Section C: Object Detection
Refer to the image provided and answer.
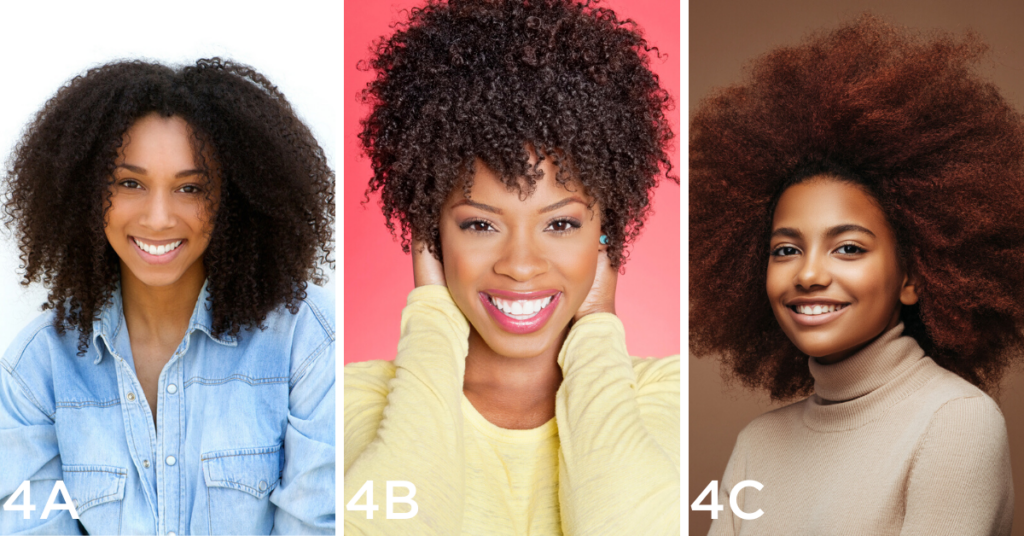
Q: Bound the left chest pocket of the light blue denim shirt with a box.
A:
[62,465,128,534]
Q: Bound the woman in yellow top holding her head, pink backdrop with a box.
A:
[345,0,680,535]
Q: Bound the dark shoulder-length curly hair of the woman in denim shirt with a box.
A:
[3,57,334,353]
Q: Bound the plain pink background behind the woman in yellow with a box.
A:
[343,0,680,363]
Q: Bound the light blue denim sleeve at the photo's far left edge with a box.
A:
[0,360,81,534]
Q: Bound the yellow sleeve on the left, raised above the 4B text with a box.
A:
[344,285,469,536]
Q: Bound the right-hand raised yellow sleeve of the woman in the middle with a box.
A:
[555,313,680,535]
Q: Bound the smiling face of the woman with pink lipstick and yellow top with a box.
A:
[439,159,601,358]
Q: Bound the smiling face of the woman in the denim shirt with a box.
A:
[103,114,216,287]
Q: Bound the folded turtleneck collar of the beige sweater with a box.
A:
[804,323,941,431]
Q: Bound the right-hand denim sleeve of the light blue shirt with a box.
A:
[270,320,336,534]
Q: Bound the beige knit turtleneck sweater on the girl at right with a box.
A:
[703,324,1021,536]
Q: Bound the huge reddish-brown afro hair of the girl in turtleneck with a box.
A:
[689,15,1024,399]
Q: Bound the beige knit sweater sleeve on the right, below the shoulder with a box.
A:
[900,397,1014,536]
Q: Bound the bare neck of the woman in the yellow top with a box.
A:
[463,326,568,412]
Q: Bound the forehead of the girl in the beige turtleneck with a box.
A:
[772,177,892,234]
